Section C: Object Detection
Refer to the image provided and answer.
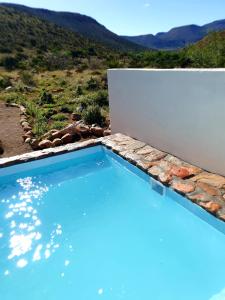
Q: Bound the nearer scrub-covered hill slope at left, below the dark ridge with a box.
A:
[0,5,123,70]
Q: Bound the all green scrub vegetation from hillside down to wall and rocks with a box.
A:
[0,6,225,143]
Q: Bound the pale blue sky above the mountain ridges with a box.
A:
[2,0,225,35]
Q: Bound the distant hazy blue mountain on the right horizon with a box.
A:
[124,20,225,50]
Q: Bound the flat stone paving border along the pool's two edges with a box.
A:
[0,133,225,221]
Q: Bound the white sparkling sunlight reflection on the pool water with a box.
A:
[0,177,62,275]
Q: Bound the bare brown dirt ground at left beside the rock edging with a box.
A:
[0,102,32,158]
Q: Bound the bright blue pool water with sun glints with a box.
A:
[0,146,225,300]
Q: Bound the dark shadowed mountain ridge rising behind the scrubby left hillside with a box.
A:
[0,3,143,51]
